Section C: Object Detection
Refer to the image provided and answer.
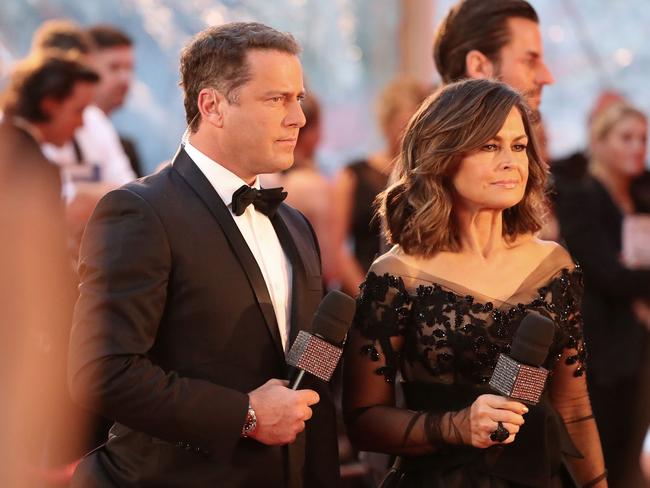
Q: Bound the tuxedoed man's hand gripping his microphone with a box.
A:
[248,379,320,446]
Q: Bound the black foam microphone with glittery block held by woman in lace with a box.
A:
[490,314,555,405]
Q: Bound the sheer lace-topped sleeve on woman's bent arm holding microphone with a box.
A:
[343,272,469,455]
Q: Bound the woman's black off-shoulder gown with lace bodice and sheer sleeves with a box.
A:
[343,258,604,488]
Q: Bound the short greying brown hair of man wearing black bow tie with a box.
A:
[180,22,300,132]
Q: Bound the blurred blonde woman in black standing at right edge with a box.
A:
[556,103,650,487]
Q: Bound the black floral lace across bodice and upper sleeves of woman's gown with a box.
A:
[353,265,585,385]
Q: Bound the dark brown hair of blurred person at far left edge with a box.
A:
[0,50,99,122]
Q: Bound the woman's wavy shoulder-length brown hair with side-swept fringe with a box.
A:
[376,80,548,257]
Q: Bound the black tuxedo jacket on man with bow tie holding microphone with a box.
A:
[69,148,338,487]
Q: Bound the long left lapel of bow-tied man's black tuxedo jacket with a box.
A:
[173,147,285,362]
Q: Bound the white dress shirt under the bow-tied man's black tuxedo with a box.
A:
[185,141,292,351]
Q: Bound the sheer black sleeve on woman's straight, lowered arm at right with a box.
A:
[549,268,606,486]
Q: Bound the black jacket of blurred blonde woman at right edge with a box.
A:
[556,176,650,386]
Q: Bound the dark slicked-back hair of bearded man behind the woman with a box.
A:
[433,0,539,83]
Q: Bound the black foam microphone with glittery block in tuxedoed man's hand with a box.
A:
[287,290,356,390]
